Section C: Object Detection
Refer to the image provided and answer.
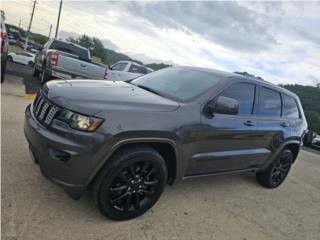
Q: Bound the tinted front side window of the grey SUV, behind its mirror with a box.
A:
[220,83,255,114]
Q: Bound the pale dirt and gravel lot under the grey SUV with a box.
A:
[1,75,320,240]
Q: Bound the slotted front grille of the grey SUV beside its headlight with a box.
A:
[33,93,59,125]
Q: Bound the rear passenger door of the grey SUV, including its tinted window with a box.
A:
[256,86,284,158]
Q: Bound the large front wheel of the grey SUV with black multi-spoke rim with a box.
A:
[93,146,168,220]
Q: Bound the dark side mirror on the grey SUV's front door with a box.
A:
[204,96,239,115]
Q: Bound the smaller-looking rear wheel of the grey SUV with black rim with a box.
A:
[256,149,293,188]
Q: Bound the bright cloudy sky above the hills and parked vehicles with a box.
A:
[1,0,320,86]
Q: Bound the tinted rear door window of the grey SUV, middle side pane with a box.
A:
[257,87,281,117]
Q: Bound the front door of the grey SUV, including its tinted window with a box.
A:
[187,82,267,175]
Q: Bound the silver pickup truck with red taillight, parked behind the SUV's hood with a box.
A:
[33,39,108,84]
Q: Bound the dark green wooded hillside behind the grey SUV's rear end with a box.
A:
[281,84,320,134]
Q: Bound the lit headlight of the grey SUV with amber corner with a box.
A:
[58,110,103,132]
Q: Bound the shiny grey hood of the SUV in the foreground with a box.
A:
[44,80,179,115]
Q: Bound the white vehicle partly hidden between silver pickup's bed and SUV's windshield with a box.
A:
[108,61,152,81]
